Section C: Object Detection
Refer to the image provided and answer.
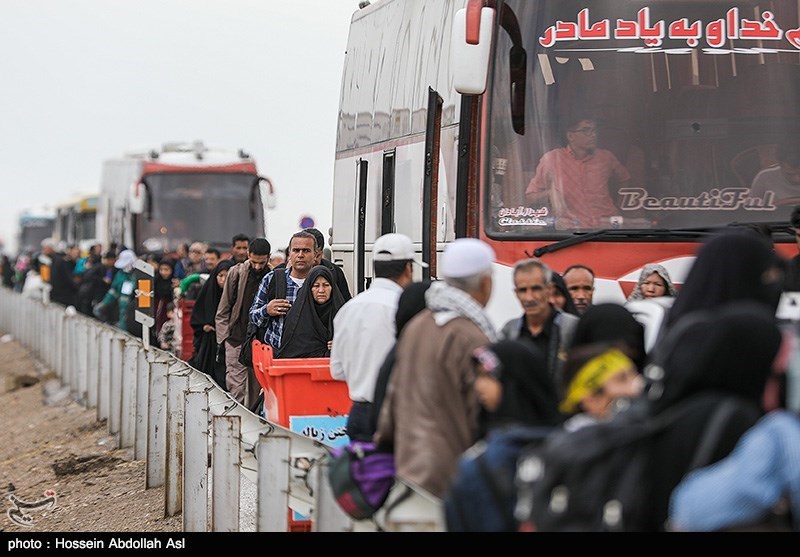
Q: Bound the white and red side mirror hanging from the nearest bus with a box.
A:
[450,4,495,95]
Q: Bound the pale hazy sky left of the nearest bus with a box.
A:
[0,0,358,254]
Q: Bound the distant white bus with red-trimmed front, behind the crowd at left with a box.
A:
[97,141,275,253]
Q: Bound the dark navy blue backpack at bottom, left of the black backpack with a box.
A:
[443,426,554,532]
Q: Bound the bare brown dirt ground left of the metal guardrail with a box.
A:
[0,331,182,532]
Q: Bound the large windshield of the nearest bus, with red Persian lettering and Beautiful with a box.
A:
[483,0,800,239]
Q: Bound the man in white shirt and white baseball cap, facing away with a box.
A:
[330,233,428,441]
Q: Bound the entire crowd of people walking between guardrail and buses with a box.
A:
[4,213,800,531]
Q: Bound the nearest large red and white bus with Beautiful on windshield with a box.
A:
[331,0,800,323]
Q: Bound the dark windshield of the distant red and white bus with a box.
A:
[136,172,264,251]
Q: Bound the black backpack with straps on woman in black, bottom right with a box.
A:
[515,311,758,532]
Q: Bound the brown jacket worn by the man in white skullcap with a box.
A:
[375,309,489,497]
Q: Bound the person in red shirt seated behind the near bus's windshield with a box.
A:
[525,115,631,230]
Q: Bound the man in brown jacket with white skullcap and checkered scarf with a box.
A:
[376,238,497,497]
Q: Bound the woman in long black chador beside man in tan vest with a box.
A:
[190,259,234,390]
